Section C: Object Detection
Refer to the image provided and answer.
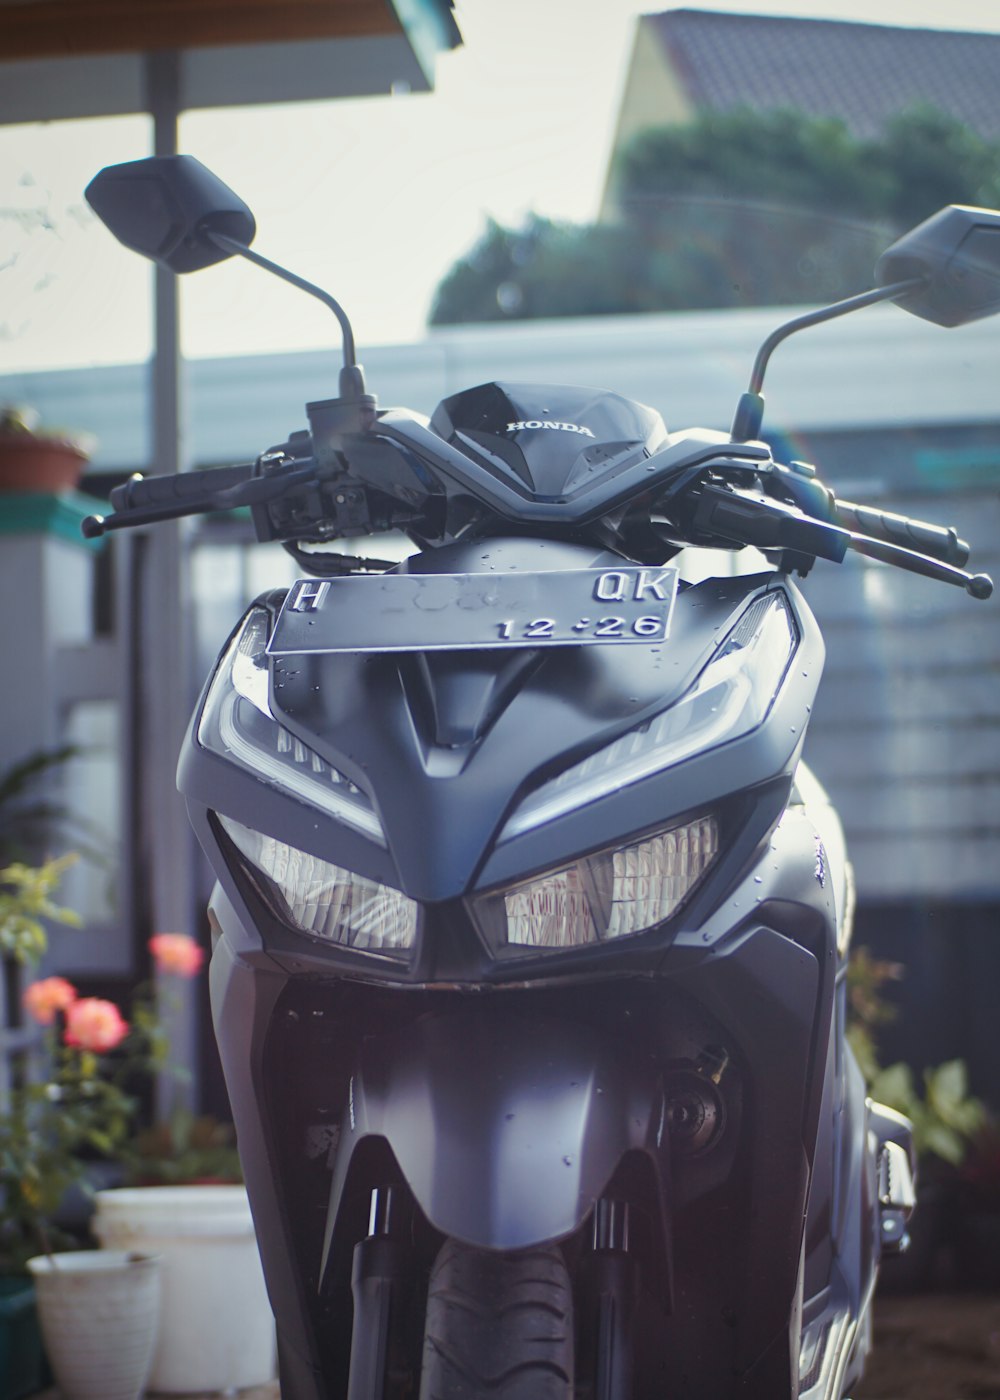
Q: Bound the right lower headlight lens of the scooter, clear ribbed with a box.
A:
[471,816,718,955]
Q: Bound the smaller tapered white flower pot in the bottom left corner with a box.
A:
[28,1249,160,1400]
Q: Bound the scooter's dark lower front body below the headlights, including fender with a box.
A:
[204,818,851,1400]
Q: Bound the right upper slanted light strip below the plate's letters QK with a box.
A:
[500,592,797,841]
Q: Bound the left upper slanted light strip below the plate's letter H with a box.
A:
[197,608,385,846]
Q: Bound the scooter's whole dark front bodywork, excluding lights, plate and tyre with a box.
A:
[181,534,870,1400]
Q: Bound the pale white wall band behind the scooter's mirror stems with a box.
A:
[0,307,1000,470]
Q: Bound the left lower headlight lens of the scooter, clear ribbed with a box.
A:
[217,813,419,958]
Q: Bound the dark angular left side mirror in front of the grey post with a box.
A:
[84,155,256,272]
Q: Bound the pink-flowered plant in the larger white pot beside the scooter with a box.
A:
[0,912,275,1400]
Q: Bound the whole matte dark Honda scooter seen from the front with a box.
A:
[85,157,1000,1400]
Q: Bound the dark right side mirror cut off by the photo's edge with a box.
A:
[875,204,1000,326]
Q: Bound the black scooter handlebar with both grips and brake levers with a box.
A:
[83,431,993,598]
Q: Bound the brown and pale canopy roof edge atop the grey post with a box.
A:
[0,0,461,123]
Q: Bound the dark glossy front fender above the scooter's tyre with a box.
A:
[325,1000,668,1254]
